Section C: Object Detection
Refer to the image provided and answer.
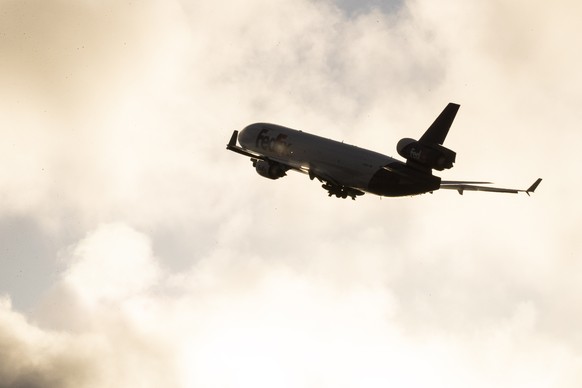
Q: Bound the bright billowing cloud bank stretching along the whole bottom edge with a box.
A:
[0,224,580,387]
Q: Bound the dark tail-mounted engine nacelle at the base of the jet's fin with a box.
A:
[396,138,457,171]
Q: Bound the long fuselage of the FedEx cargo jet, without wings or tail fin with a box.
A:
[238,123,440,197]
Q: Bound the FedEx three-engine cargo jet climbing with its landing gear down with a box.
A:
[226,103,542,200]
